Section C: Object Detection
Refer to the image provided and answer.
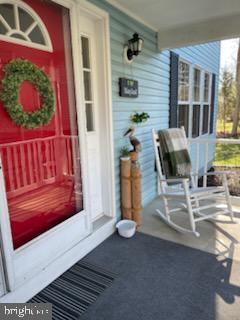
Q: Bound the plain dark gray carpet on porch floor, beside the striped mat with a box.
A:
[80,233,240,320]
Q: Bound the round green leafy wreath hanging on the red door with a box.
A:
[0,59,55,129]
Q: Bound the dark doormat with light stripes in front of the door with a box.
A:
[29,259,116,320]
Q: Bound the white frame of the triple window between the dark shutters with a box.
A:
[177,58,212,139]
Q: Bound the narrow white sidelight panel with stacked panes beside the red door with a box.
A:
[80,14,104,221]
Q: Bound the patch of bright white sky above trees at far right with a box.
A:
[220,39,238,74]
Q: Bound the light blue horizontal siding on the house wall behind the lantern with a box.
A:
[89,0,218,217]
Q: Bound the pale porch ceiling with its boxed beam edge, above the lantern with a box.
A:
[107,0,240,50]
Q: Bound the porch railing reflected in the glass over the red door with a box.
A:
[0,136,80,197]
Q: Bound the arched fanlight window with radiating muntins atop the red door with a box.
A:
[0,0,52,51]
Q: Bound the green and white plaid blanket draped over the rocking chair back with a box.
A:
[159,128,192,178]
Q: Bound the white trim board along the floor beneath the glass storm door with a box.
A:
[0,219,116,303]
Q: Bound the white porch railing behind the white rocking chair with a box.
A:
[188,138,240,196]
